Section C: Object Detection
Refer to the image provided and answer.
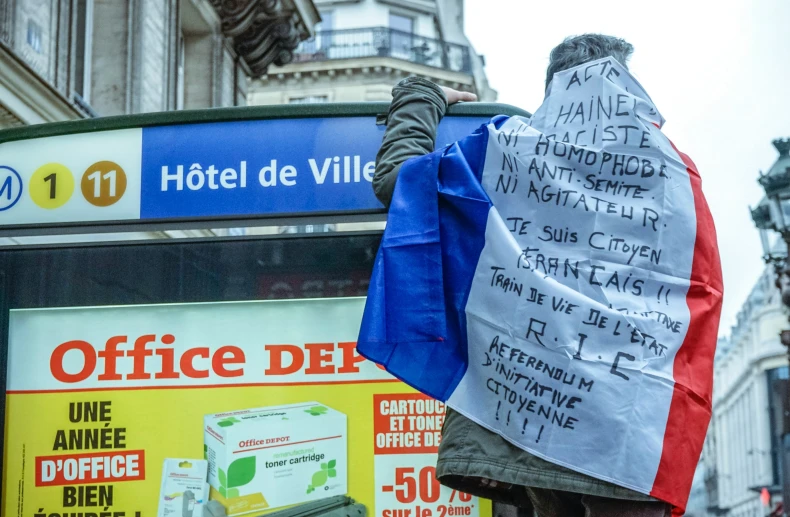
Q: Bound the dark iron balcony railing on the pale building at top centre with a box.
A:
[292,27,472,74]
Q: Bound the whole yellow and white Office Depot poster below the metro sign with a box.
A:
[0,298,490,517]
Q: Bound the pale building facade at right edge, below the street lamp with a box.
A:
[703,267,788,517]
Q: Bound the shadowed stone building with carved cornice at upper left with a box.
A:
[0,0,319,127]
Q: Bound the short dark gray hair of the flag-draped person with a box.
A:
[546,34,634,89]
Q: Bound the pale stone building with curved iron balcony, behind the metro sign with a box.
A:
[250,0,496,104]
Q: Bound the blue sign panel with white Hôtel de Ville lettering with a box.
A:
[140,117,488,220]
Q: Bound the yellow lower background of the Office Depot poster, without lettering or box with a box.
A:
[3,382,490,517]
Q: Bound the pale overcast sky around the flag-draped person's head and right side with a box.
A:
[465,0,790,334]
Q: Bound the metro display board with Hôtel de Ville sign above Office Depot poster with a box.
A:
[0,103,532,517]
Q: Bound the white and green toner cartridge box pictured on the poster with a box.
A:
[204,402,348,515]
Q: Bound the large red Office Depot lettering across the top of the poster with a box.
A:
[49,334,372,384]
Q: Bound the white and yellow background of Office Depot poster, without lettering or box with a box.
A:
[1,298,490,517]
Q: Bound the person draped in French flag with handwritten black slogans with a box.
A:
[358,35,723,517]
